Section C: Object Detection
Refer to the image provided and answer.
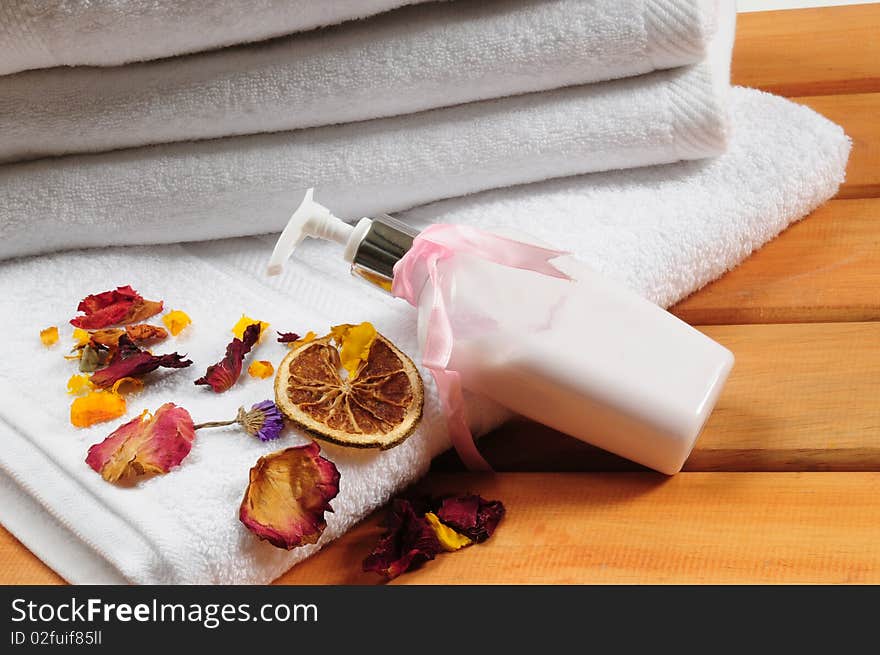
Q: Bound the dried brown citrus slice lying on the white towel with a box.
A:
[275,333,424,450]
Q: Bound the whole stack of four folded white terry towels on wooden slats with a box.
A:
[0,0,849,582]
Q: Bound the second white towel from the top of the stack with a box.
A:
[0,0,720,162]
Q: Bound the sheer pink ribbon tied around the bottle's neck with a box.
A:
[391,224,571,471]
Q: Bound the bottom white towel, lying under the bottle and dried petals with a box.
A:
[0,89,849,583]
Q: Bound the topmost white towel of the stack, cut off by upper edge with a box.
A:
[0,0,425,75]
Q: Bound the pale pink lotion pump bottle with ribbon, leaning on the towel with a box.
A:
[269,189,733,474]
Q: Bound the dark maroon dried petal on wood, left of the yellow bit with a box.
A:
[363,498,443,580]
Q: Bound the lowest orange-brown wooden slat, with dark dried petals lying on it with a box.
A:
[279,473,880,584]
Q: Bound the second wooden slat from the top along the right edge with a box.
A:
[795,93,880,198]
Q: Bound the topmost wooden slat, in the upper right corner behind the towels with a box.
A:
[733,4,880,96]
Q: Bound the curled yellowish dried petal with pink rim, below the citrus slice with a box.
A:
[238,442,339,550]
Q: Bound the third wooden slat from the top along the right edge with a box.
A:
[671,199,880,325]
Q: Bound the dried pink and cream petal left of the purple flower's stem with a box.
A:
[86,403,196,482]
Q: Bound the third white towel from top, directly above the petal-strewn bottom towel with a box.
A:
[0,8,733,258]
